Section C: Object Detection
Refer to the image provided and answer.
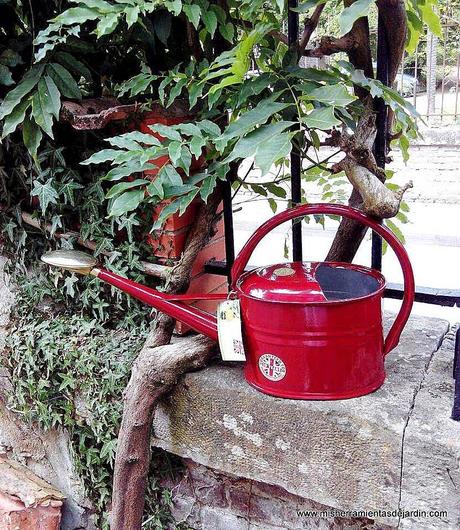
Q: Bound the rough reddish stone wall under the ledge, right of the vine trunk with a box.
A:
[165,460,390,530]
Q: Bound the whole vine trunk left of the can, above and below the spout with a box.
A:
[110,186,221,530]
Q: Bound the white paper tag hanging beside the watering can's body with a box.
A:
[217,300,246,361]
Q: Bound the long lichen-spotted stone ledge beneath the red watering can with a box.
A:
[154,317,460,528]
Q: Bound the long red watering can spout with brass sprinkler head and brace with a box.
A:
[41,250,219,341]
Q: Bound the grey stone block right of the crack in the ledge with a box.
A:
[400,328,460,530]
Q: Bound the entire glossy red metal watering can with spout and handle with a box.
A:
[42,204,414,399]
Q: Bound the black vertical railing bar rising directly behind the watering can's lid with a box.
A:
[288,0,302,261]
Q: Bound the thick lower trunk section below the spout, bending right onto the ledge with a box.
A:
[111,335,216,530]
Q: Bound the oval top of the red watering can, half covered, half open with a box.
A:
[235,261,385,304]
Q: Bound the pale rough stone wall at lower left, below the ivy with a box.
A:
[0,256,95,530]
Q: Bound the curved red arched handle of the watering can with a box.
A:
[231,204,415,355]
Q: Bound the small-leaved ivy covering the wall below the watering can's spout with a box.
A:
[4,284,184,530]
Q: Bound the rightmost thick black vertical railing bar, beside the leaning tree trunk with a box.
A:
[371,15,388,270]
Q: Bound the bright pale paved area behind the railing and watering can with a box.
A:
[235,142,460,321]
